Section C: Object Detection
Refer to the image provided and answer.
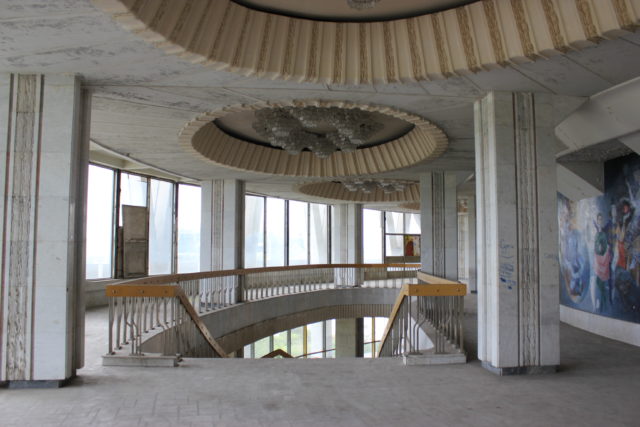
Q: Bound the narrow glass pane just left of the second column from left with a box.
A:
[178,184,200,273]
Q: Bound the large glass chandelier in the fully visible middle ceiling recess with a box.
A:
[253,107,384,158]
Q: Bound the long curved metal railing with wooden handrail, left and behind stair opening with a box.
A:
[106,264,420,357]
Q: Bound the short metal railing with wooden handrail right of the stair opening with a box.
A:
[378,272,467,357]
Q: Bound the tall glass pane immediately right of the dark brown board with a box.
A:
[149,179,174,274]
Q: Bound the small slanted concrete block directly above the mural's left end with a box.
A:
[556,162,604,202]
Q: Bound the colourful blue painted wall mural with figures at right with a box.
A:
[558,154,640,323]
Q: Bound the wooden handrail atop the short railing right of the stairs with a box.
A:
[377,271,467,357]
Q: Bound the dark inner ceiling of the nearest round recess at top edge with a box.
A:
[233,0,474,21]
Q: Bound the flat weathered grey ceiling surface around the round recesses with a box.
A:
[0,0,640,205]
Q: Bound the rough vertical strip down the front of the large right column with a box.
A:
[513,93,540,366]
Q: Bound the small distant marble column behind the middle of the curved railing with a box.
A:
[331,203,363,286]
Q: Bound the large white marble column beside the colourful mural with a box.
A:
[475,92,560,374]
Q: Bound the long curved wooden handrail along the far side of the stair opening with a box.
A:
[116,263,421,285]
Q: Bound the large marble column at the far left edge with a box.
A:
[0,74,90,387]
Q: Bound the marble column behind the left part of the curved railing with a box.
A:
[200,179,244,305]
